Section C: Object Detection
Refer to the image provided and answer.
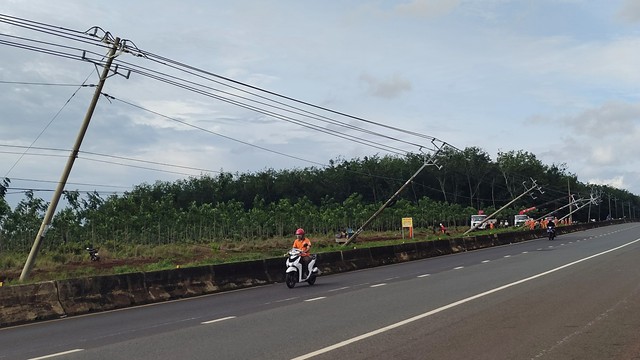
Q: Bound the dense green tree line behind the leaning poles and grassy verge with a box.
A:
[0,147,640,251]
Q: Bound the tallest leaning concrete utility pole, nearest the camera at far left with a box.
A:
[20,38,120,281]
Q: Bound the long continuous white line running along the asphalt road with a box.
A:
[291,239,640,360]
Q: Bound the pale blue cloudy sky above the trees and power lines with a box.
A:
[0,0,640,210]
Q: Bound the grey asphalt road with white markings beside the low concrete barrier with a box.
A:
[0,223,640,360]
